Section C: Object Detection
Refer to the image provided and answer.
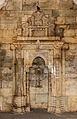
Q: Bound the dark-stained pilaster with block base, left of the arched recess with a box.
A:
[13,45,26,113]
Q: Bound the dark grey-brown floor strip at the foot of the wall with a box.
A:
[0,110,77,119]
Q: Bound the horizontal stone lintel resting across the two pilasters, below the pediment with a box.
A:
[10,41,64,50]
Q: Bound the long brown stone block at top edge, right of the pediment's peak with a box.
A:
[39,0,73,9]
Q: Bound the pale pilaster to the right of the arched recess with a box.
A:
[53,47,62,113]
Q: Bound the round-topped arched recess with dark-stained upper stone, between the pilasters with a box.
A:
[29,56,48,109]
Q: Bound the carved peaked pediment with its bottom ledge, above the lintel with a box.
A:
[13,10,63,40]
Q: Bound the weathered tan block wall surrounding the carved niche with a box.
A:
[0,0,77,111]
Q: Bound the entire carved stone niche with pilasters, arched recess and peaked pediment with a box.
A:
[11,11,68,113]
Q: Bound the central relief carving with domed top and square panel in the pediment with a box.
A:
[27,11,55,37]
